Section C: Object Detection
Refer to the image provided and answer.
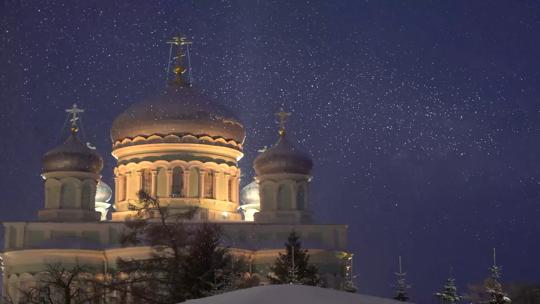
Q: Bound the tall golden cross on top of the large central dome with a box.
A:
[167,36,193,86]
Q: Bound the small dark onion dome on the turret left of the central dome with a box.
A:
[42,132,103,174]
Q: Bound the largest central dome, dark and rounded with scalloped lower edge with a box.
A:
[111,86,246,144]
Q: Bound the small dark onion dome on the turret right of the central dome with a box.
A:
[253,133,313,175]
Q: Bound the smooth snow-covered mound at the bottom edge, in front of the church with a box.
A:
[185,285,412,304]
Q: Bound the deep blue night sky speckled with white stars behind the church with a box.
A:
[0,0,540,303]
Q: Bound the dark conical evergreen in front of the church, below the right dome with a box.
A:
[268,231,322,286]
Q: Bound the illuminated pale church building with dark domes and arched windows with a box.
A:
[1,70,351,301]
